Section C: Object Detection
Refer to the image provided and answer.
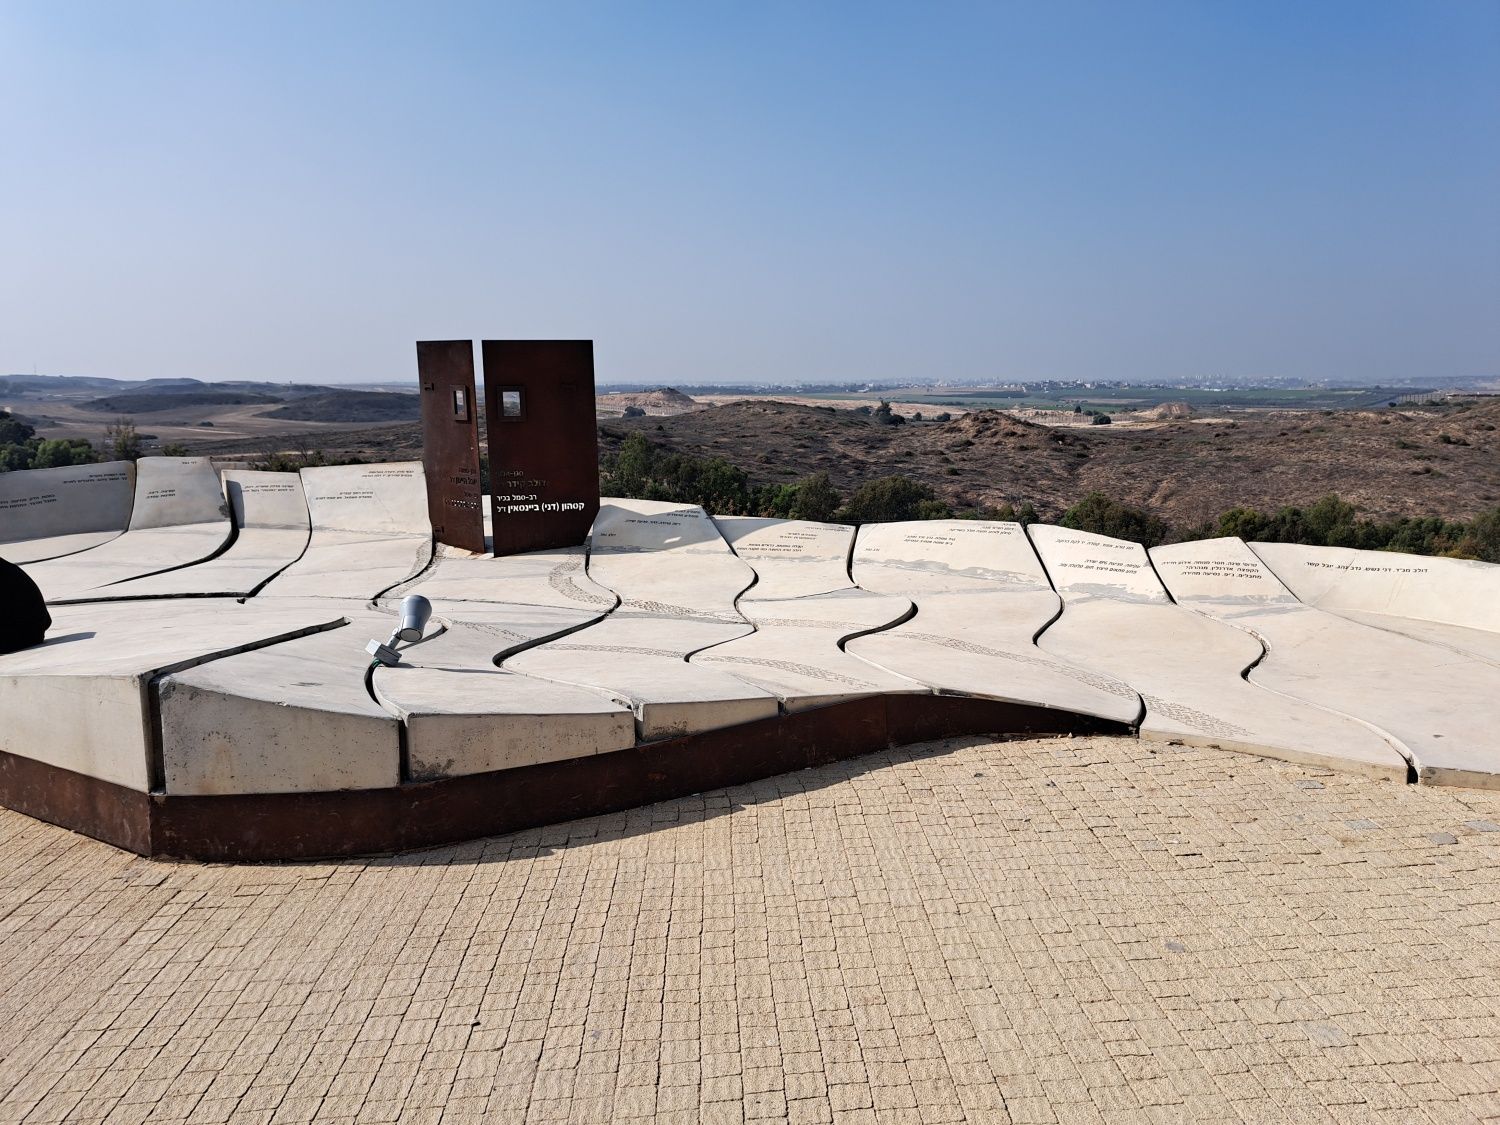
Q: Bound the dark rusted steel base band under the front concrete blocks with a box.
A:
[0,696,1128,863]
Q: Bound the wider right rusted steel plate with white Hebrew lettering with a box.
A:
[483,341,599,555]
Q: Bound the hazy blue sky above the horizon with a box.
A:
[0,0,1500,383]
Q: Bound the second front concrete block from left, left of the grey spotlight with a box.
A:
[156,599,401,795]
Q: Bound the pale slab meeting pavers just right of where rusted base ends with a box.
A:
[1028,524,1407,779]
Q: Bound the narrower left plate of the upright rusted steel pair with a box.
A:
[417,341,485,554]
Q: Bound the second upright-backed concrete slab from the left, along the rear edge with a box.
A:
[26,458,234,603]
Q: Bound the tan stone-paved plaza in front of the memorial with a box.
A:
[0,740,1500,1125]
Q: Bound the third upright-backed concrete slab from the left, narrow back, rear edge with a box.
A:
[69,470,309,600]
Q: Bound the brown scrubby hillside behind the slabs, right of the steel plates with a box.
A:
[600,399,1500,524]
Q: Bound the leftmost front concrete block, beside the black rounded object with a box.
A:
[0,600,342,791]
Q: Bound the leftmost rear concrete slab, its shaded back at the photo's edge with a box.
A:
[0,461,135,566]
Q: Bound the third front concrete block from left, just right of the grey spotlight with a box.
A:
[374,618,636,782]
